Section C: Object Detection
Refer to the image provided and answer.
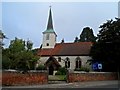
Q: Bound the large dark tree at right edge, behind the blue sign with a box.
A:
[90,18,120,71]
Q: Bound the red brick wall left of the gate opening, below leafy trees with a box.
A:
[2,71,48,86]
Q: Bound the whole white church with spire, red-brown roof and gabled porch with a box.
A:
[37,7,92,75]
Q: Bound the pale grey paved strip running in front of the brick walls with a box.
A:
[3,81,118,90]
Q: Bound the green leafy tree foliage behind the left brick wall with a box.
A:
[3,38,38,71]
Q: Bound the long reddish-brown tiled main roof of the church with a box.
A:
[38,42,92,56]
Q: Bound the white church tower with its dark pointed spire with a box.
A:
[42,6,57,49]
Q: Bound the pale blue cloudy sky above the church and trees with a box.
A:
[0,1,118,48]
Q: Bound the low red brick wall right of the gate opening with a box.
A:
[67,72,117,83]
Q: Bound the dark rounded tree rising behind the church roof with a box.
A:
[80,27,96,42]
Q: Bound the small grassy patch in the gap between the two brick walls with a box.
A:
[48,75,66,81]
